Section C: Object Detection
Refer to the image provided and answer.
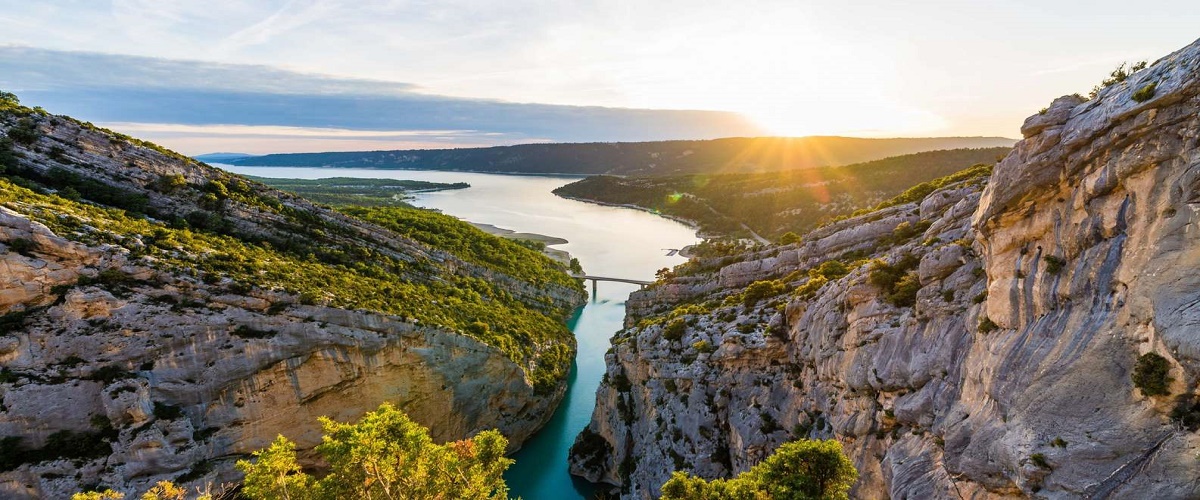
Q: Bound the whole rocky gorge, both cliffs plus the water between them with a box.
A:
[0,33,1200,499]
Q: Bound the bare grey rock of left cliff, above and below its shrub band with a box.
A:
[0,104,583,499]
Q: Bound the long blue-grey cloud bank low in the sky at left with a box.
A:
[0,46,761,152]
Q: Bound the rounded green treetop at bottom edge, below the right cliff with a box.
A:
[662,439,858,500]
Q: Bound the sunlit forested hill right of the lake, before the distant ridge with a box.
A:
[554,147,1009,239]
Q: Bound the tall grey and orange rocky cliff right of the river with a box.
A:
[571,42,1200,499]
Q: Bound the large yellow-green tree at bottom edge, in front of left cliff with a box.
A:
[238,403,512,500]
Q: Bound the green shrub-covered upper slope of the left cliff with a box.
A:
[0,95,582,391]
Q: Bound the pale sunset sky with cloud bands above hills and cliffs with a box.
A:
[0,0,1200,153]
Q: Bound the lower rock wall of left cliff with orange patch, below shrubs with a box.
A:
[0,207,563,498]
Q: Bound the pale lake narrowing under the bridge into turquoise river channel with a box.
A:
[218,165,698,500]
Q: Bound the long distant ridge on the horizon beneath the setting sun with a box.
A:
[229,137,1013,176]
